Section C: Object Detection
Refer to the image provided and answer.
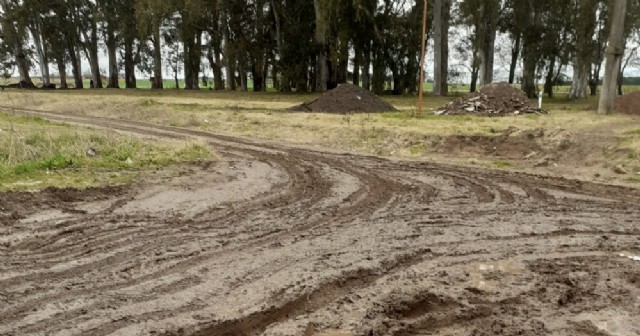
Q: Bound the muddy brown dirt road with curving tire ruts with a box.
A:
[0,111,640,335]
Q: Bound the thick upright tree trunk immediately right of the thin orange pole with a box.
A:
[433,0,451,96]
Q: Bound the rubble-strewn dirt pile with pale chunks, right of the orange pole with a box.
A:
[435,83,546,117]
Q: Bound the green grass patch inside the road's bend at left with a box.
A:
[0,113,212,189]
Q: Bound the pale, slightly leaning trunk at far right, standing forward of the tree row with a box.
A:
[598,0,627,114]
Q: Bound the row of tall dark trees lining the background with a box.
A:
[0,0,640,98]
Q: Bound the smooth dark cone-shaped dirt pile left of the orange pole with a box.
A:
[289,84,397,113]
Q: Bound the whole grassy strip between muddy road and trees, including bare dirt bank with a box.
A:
[4,90,640,183]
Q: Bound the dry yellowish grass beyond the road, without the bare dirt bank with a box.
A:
[2,90,640,182]
